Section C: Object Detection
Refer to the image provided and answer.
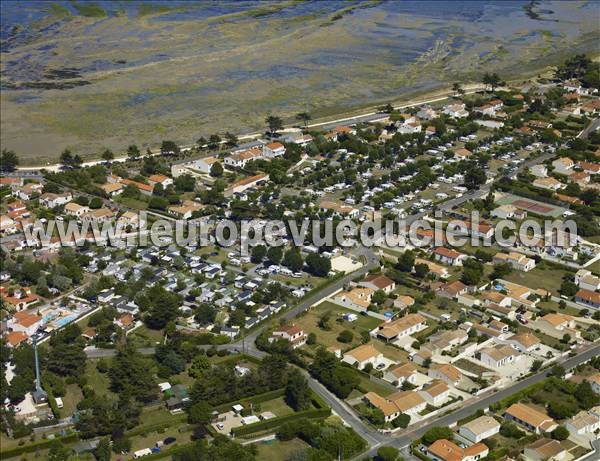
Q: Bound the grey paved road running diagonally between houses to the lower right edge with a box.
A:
[357,344,600,459]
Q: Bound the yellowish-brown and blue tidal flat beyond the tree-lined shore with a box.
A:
[1,0,598,164]
